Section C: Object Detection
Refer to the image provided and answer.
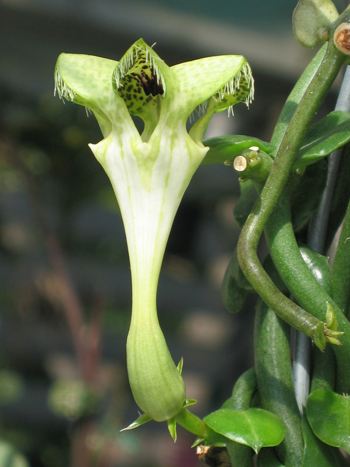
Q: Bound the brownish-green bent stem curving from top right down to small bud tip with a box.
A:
[238,42,344,348]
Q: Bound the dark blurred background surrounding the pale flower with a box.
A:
[0,0,343,467]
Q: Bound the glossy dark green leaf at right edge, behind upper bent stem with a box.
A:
[294,111,350,169]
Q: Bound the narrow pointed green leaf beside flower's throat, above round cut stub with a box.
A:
[202,135,273,164]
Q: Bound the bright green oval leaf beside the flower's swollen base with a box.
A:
[204,408,285,452]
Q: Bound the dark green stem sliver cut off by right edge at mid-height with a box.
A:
[331,199,350,316]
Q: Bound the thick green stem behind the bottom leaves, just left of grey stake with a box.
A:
[255,302,304,467]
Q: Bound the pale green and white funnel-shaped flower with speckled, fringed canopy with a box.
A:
[55,39,254,421]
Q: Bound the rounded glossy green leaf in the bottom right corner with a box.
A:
[306,389,350,453]
